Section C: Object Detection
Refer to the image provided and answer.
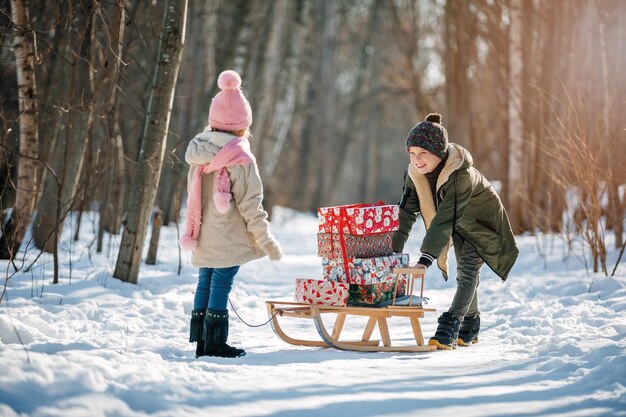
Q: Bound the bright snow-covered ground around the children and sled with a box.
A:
[0,209,626,417]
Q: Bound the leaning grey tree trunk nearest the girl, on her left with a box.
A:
[113,0,187,284]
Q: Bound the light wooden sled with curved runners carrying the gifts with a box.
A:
[265,268,436,352]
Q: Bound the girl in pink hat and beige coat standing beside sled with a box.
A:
[180,70,282,358]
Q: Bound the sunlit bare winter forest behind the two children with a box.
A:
[0,0,626,281]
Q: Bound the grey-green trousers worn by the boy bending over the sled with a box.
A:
[448,234,484,321]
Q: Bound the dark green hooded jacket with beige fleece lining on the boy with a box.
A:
[393,143,519,280]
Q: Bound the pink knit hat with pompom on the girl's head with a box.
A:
[209,70,252,131]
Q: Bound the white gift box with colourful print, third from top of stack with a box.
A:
[322,253,409,285]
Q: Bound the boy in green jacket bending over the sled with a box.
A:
[393,114,519,349]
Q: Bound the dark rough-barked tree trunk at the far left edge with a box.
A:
[0,0,39,259]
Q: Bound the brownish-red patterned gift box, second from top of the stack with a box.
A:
[317,232,393,258]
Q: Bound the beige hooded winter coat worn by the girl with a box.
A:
[185,130,272,268]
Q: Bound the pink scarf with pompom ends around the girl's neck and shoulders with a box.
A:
[180,137,255,250]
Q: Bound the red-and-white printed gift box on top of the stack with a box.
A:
[317,202,400,235]
